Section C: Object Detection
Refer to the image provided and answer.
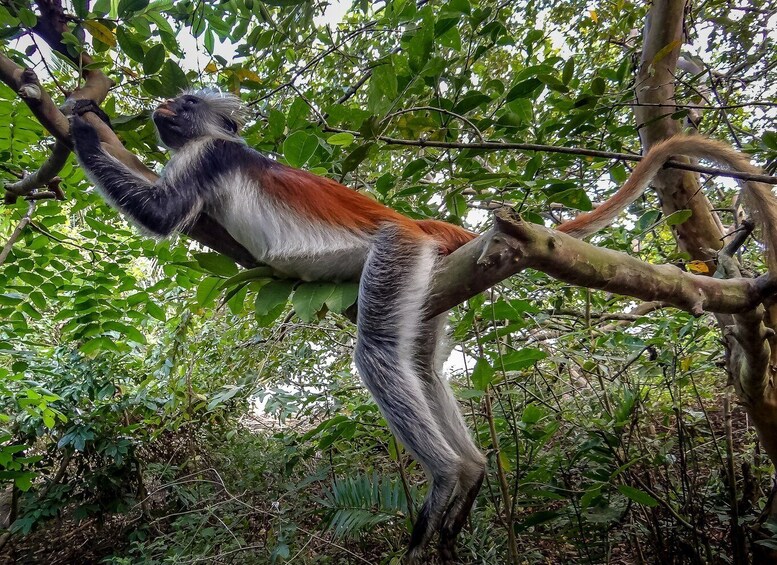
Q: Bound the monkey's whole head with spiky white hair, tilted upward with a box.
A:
[151,90,245,150]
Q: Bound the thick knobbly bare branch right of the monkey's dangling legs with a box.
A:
[429,208,777,316]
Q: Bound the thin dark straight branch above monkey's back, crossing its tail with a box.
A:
[324,126,777,184]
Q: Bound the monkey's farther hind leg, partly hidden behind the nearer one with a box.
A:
[417,314,486,563]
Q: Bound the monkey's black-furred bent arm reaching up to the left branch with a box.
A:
[70,116,203,236]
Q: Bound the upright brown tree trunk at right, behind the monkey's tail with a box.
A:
[634,0,777,563]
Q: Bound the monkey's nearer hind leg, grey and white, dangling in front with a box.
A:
[355,225,462,563]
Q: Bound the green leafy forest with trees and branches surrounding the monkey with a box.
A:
[0,0,777,563]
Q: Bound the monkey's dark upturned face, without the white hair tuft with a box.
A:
[151,94,237,149]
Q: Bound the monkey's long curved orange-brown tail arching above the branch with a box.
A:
[557,135,777,272]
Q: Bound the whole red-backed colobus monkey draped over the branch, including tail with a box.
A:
[71,92,777,563]
